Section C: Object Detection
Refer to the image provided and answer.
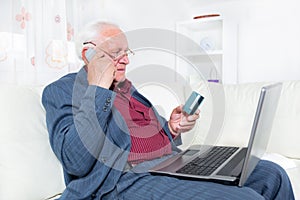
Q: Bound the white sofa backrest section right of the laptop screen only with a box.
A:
[268,81,300,159]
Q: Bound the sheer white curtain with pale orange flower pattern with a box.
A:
[0,0,103,85]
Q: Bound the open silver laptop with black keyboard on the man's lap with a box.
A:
[149,83,282,187]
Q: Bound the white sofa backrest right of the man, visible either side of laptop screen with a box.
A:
[183,81,300,159]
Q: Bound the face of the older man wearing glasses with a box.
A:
[97,27,129,84]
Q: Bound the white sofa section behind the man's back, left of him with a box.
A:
[0,85,64,200]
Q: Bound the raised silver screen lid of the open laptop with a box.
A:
[239,83,282,186]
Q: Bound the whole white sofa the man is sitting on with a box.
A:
[0,81,300,200]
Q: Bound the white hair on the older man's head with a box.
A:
[75,21,119,60]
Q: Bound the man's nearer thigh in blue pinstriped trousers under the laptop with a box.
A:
[117,174,264,200]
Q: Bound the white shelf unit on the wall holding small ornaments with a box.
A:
[176,16,237,83]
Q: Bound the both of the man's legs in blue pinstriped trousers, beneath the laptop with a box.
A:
[105,161,290,200]
